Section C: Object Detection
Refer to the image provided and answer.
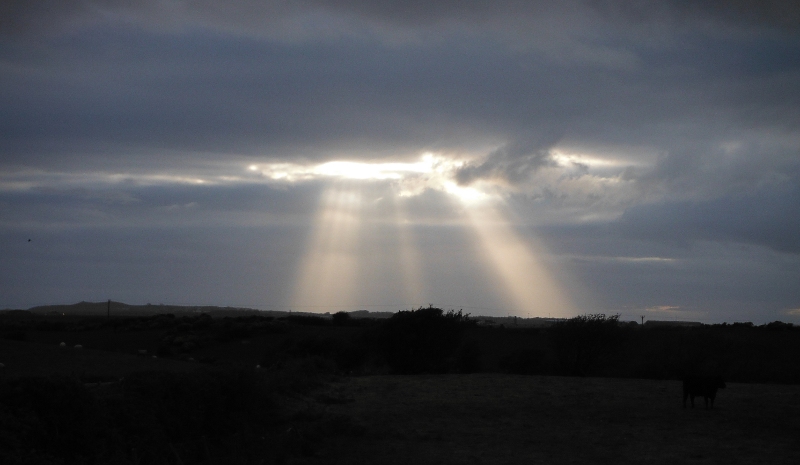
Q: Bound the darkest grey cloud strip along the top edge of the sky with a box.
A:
[0,0,800,36]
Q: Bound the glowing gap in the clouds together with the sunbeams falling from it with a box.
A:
[248,149,575,316]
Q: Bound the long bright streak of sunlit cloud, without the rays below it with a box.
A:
[0,146,646,227]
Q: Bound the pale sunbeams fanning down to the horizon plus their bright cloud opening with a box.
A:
[284,154,575,317]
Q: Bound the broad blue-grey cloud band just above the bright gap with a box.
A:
[0,21,800,168]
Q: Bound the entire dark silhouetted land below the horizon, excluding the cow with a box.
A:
[0,308,800,465]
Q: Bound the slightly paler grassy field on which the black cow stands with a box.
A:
[303,374,800,464]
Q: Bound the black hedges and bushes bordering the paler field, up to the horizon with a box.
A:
[0,307,800,464]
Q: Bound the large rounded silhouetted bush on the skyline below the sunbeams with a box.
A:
[378,307,472,373]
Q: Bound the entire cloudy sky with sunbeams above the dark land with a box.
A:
[0,0,800,324]
